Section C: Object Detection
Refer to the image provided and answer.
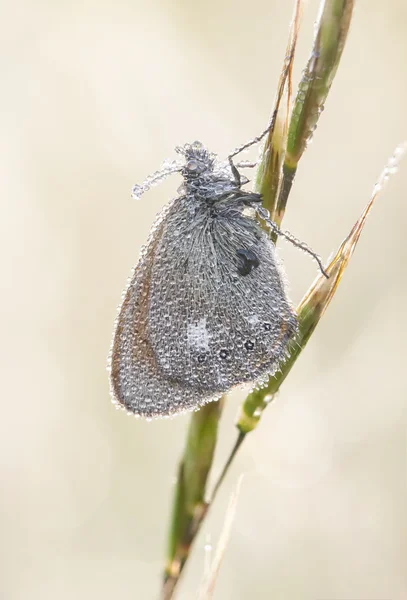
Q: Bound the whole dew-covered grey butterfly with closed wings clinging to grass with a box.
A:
[109,138,322,418]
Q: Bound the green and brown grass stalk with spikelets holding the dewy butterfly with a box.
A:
[161,0,356,600]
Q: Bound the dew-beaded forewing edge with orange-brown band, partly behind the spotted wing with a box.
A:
[110,199,219,417]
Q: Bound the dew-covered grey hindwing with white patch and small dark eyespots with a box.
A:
[148,197,297,393]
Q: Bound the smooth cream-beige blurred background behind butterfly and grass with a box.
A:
[0,0,407,600]
